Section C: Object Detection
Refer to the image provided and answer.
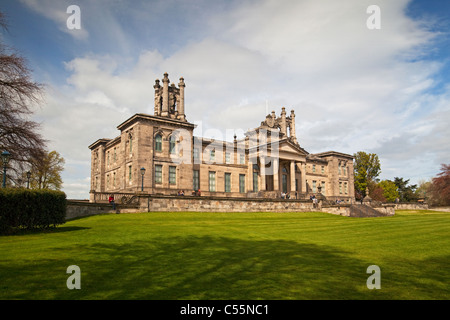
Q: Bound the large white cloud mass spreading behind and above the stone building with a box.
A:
[24,0,450,198]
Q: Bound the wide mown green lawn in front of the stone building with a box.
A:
[0,211,450,300]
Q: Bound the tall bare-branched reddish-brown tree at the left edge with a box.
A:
[0,12,46,180]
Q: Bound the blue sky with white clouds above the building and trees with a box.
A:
[0,0,450,199]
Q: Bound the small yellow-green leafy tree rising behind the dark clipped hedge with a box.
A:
[30,151,65,190]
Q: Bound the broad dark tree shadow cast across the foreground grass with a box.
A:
[0,236,445,300]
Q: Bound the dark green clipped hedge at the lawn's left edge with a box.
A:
[0,188,66,233]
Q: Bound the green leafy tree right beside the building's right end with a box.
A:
[353,151,381,196]
